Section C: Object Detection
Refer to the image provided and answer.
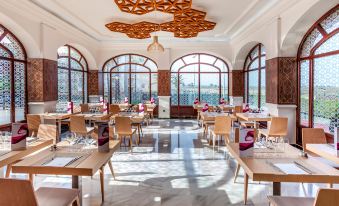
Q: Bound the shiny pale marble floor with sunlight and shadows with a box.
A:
[0,119,334,206]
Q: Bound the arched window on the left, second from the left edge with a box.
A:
[58,45,88,110]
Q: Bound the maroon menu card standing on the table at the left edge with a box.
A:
[11,123,28,151]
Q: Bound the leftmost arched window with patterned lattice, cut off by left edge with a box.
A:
[0,24,27,125]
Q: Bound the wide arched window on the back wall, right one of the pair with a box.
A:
[171,53,229,106]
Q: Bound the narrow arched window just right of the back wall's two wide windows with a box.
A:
[244,44,266,108]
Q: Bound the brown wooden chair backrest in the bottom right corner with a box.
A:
[314,188,339,206]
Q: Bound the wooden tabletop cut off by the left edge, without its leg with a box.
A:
[0,139,53,168]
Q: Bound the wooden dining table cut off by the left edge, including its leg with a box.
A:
[0,138,53,177]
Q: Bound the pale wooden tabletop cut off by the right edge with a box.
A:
[306,144,339,165]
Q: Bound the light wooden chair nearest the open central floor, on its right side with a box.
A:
[210,116,232,149]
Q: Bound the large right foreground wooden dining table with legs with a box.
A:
[227,143,339,204]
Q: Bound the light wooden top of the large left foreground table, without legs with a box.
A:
[12,140,120,176]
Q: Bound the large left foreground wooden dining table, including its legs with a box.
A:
[12,140,120,202]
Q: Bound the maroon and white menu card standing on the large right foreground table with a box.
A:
[239,128,255,157]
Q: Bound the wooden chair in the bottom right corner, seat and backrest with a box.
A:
[268,189,339,206]
